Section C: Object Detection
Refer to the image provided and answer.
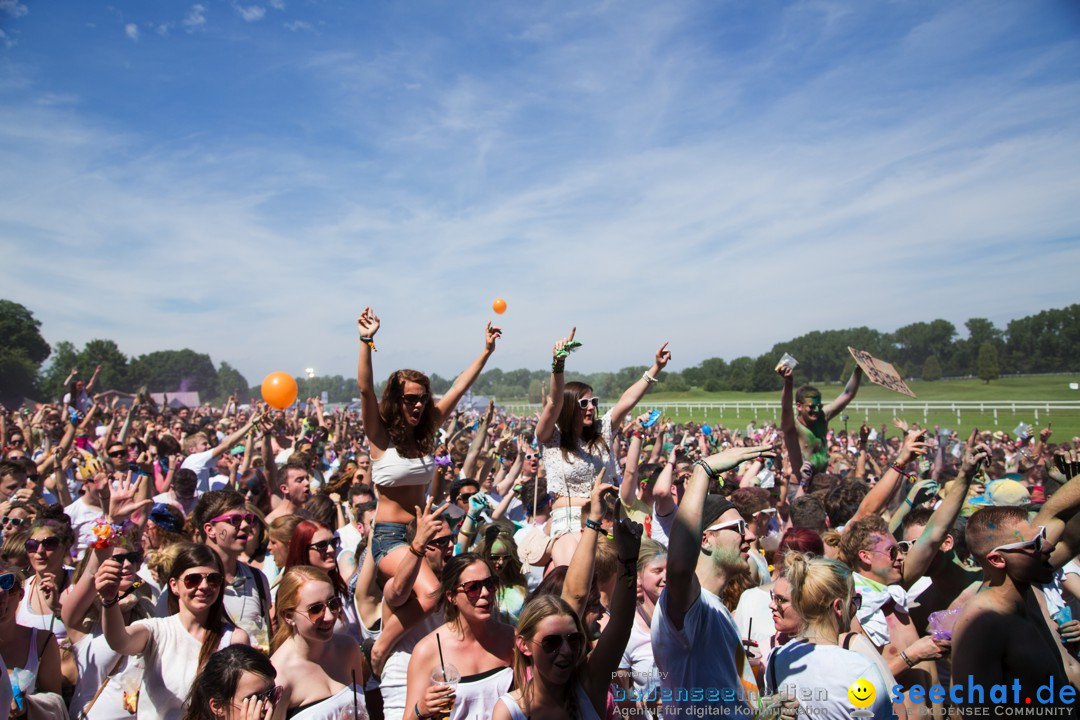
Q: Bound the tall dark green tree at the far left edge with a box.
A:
[0,300,52,407]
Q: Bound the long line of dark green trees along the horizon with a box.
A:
[0,300,1080,407]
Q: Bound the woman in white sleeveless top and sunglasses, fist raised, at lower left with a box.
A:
[94,543,249,720]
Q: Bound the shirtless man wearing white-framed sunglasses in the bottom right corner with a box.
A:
[953,459,1080,718]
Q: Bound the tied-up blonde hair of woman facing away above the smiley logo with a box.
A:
[784,553,855,633]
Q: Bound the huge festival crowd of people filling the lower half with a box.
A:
[0,309,1080,720]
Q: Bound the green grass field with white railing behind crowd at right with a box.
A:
[642,373,1080,441]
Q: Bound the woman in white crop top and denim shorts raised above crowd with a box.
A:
[356,308,502,674]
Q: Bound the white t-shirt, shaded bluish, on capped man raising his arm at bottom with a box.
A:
[651,587,753,717]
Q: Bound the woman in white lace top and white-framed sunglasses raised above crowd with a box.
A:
[536,328,672,536]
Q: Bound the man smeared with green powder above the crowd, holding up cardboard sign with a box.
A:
[777,365,863,473]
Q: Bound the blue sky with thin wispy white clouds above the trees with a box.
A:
[0,0,1080,382]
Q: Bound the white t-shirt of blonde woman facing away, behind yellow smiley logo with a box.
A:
[765,640,892,720]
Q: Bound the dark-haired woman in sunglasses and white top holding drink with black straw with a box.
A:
[405,553,514,720]
